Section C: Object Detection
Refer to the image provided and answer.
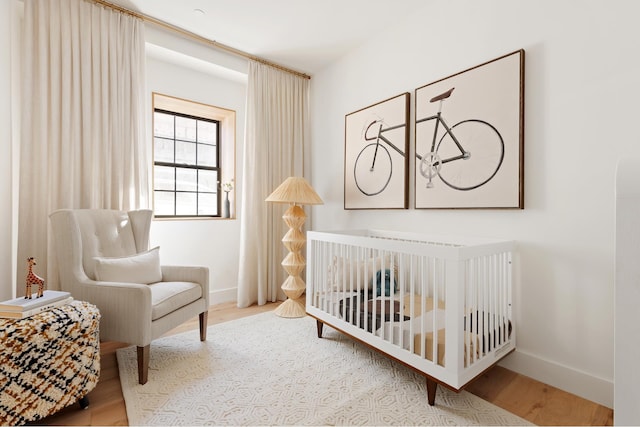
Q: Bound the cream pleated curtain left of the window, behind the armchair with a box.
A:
[17,0,150,295]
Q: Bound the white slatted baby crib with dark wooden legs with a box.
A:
[306,230,516,405]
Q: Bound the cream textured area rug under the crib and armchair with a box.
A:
[117,312,530,425]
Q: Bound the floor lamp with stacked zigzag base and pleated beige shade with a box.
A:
[266,176,323,317]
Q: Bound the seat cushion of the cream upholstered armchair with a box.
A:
[149,282,202,320]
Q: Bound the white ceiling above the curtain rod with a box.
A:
[110,0,427,74]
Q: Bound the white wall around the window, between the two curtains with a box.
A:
[147,39,246,304]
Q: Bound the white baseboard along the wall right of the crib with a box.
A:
[499,350,613,408]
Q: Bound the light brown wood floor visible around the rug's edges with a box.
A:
[38,303,613,426]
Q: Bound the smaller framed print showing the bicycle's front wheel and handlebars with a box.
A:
[344,92,410,209]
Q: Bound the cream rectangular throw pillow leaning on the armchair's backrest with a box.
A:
[94,247,162,284]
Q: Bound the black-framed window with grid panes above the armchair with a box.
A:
[153,109,221,218]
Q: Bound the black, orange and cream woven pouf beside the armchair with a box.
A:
[0,301,100,425]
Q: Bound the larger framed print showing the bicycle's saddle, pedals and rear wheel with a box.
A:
[415,50,524,209]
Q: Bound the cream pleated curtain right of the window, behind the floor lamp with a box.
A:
[238,61,309,307]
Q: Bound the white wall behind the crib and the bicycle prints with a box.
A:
[311,0,640,407]
